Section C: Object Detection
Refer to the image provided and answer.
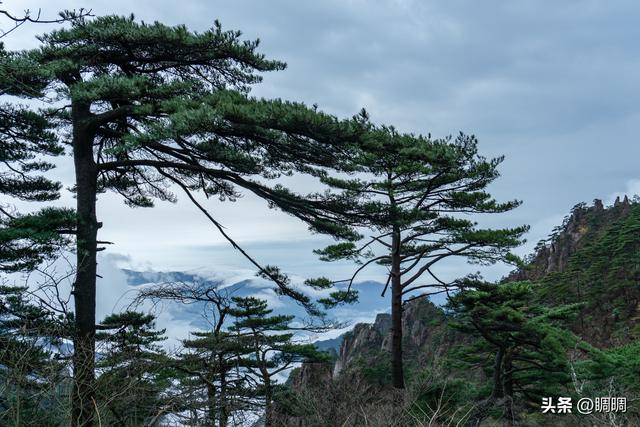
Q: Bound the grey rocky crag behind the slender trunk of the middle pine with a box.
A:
[276,298,461,427]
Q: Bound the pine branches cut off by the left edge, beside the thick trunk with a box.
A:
[0,70,74,272]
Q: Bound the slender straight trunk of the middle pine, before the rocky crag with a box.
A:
[391,225,404,389]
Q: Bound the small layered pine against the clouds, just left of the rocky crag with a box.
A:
[230,297,329,427]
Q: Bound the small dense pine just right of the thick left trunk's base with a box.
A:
[96,311,171,426]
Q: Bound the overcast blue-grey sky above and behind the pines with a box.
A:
[3,0,640,342]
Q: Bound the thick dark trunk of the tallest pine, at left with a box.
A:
[72,105,99,427]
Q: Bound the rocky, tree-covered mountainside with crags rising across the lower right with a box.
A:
[278,197,640,427]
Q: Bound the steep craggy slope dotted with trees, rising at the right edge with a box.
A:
[506,196,640,348]
